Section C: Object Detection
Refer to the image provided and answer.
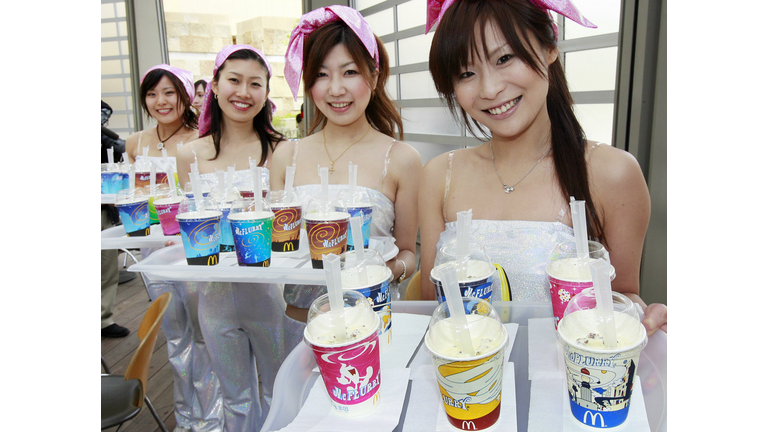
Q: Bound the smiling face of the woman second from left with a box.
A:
[211,59,269,122]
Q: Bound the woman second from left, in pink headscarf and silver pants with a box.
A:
[177,45,286,432]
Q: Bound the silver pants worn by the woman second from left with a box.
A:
[199,282,288,432]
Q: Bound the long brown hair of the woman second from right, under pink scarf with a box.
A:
[302,21,403,140]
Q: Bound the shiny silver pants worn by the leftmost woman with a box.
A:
[147,281,223,432]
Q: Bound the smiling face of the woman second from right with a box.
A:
[311,44,375,126]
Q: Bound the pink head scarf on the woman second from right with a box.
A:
[285,5,379,100]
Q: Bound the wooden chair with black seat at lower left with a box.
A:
[101,292,171,432]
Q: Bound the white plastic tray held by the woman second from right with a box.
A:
[128,230,398,285]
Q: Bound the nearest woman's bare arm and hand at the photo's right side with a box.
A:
[588,145,667,334]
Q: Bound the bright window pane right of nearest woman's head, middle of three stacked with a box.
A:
[565,47,619,92]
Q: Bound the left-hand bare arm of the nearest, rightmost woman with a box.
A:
[419,154,448,300]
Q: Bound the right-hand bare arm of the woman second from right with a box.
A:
[387,142,421,280]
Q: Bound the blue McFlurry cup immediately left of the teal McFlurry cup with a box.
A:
[176,211,221,265]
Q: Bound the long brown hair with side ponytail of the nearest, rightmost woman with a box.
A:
[429,0,605,245]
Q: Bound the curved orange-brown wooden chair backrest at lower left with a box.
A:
[125,292,171,407]
